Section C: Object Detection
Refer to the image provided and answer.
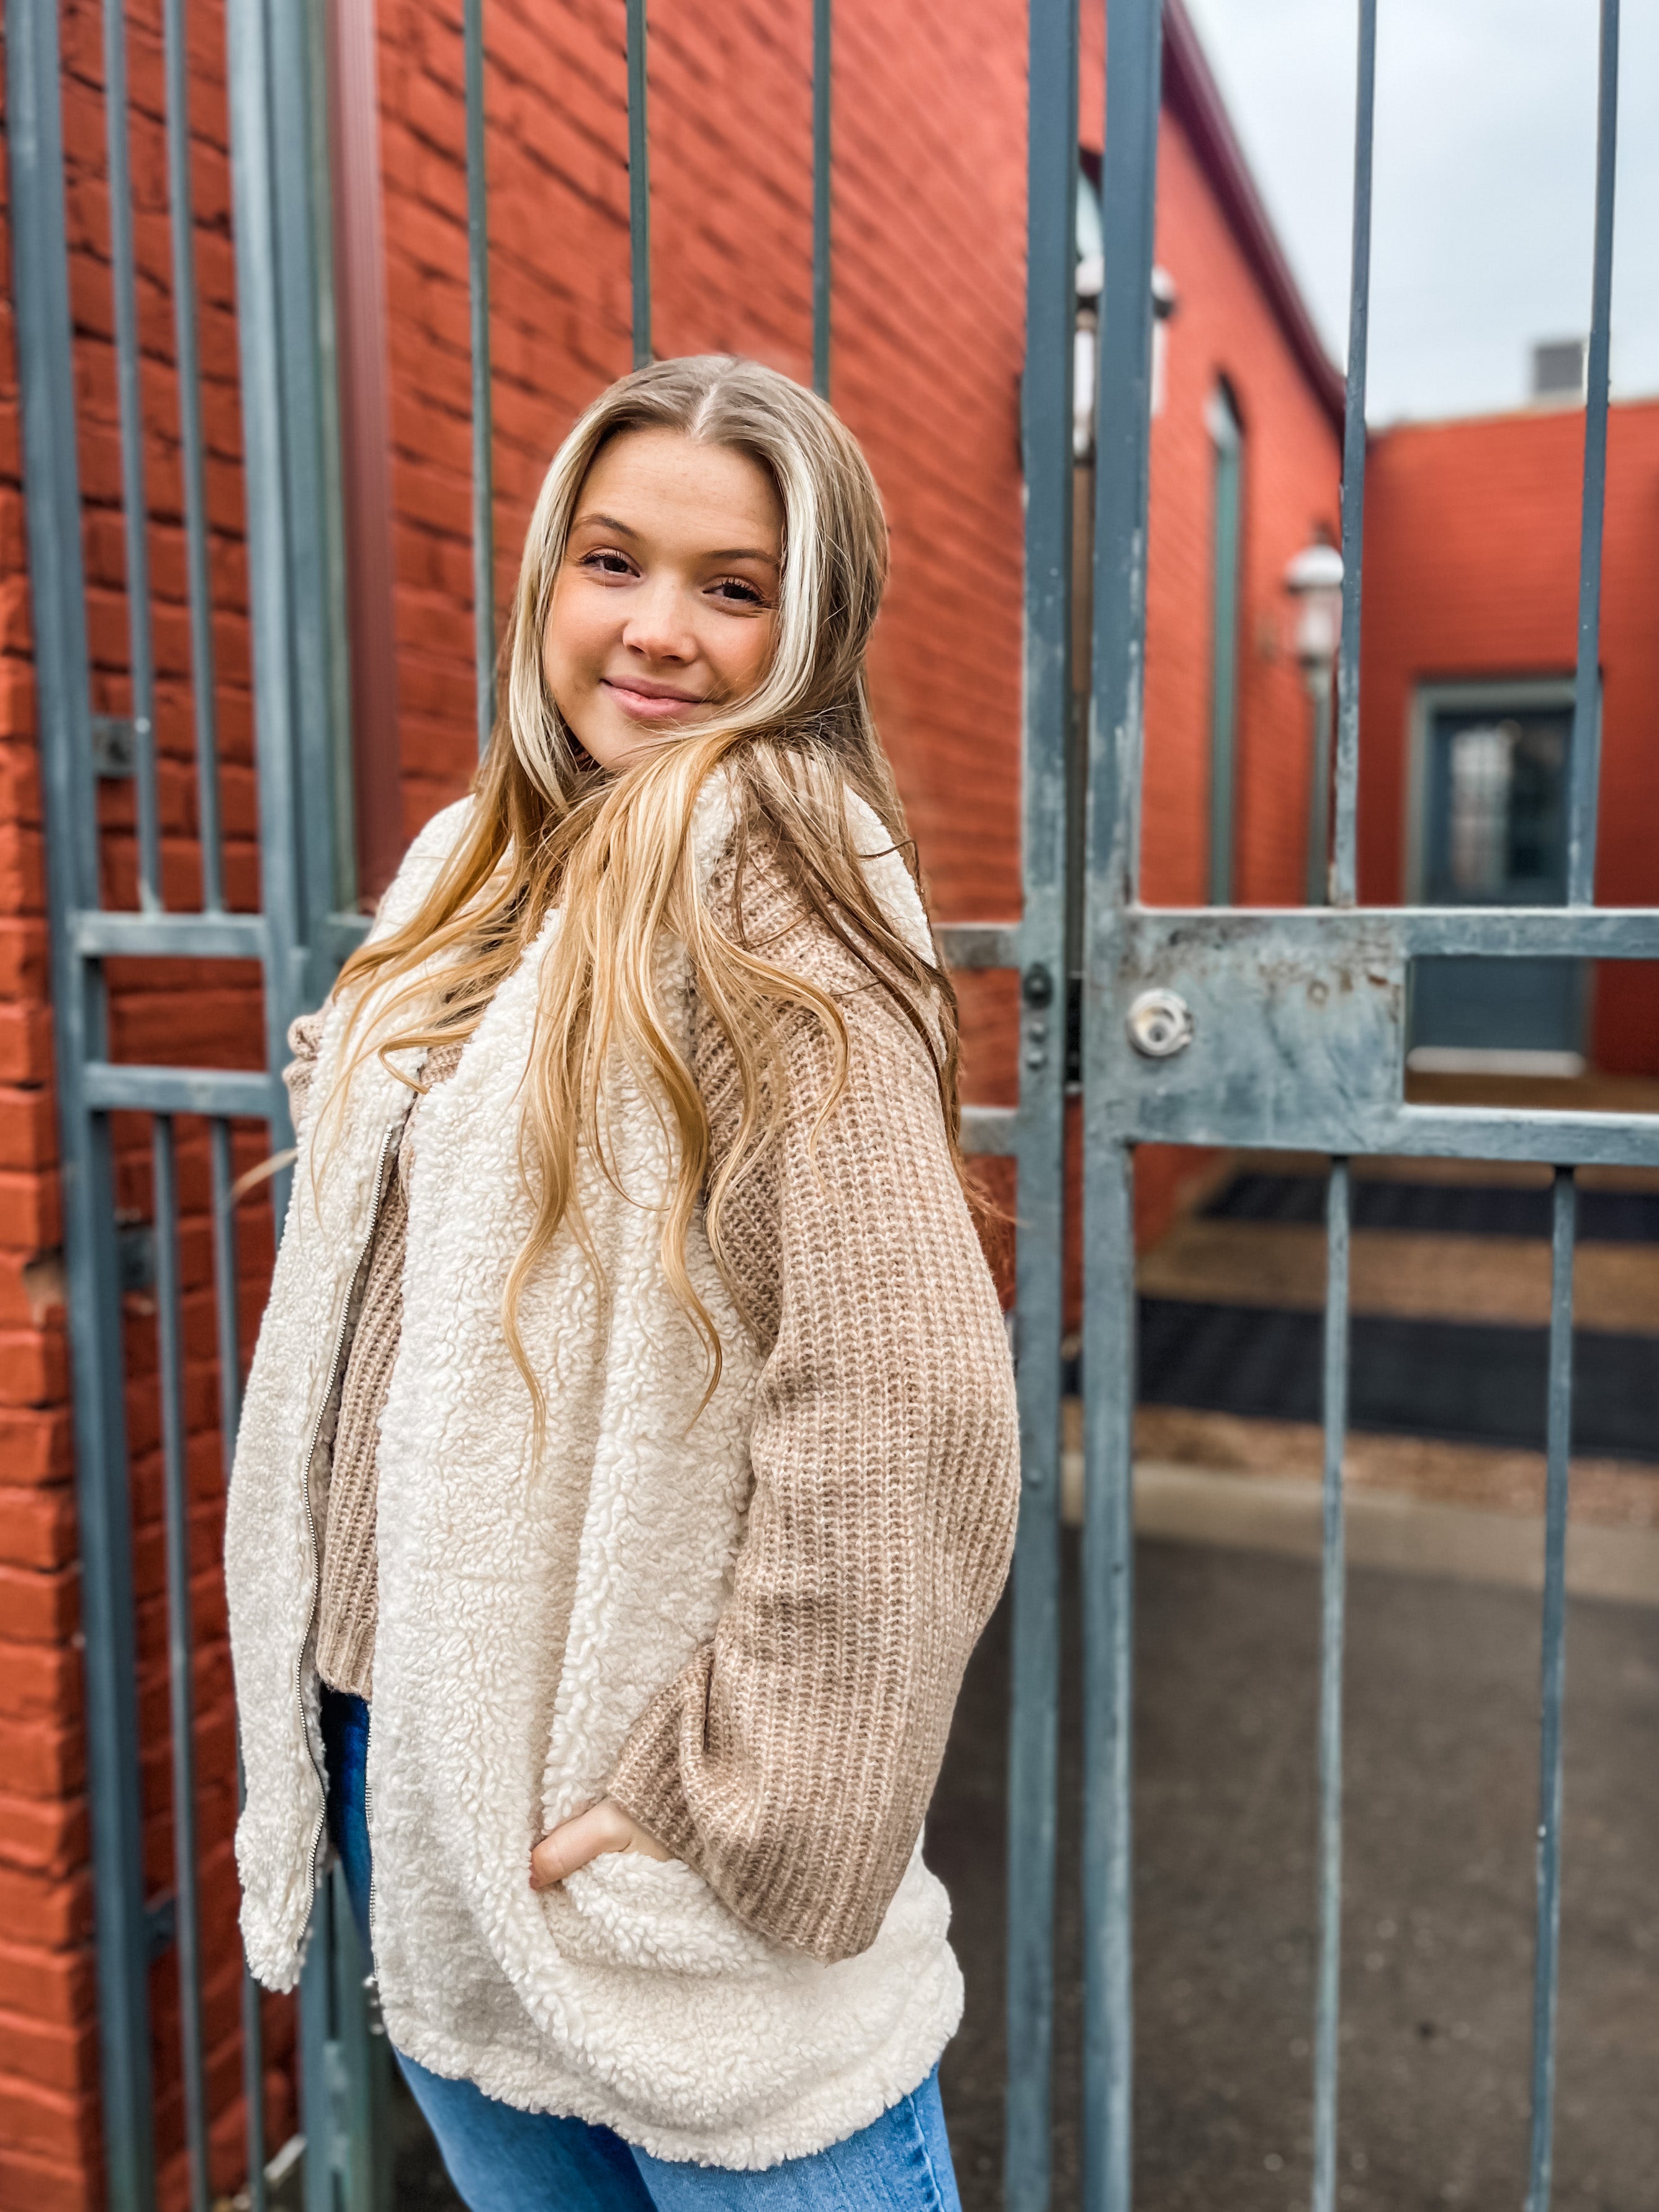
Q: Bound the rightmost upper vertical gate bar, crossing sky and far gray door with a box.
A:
[1566,0,1619,907]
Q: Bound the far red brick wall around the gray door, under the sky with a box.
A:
[1360,400,1659,1073]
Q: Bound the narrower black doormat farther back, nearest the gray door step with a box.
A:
[1203,1168,1659,1248]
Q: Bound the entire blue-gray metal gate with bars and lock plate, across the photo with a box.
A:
[7,0,1659,2212]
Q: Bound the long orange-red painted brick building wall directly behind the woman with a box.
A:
[0,0,1338,2212]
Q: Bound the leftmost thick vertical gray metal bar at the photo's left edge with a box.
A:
[7,0,155,2212]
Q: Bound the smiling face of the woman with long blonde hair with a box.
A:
[542,429,783,772]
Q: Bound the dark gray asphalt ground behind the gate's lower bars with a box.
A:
[396,1537,1659,2212]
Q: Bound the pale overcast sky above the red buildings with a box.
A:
[1188,0,1659,423]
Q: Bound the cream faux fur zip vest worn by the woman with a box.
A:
[226,783,962,2168]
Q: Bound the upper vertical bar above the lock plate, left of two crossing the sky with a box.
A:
[1332,0,1376,907]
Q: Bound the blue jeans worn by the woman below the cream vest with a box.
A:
[323,1690,962,2212]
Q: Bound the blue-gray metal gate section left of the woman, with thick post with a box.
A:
[7,0,383,2212]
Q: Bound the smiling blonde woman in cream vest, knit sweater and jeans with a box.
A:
[226,358,1017,2212]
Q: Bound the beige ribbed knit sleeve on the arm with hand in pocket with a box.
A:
[611,840,1020,1960]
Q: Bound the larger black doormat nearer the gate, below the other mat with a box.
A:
[1139,1300,1659,1462]
